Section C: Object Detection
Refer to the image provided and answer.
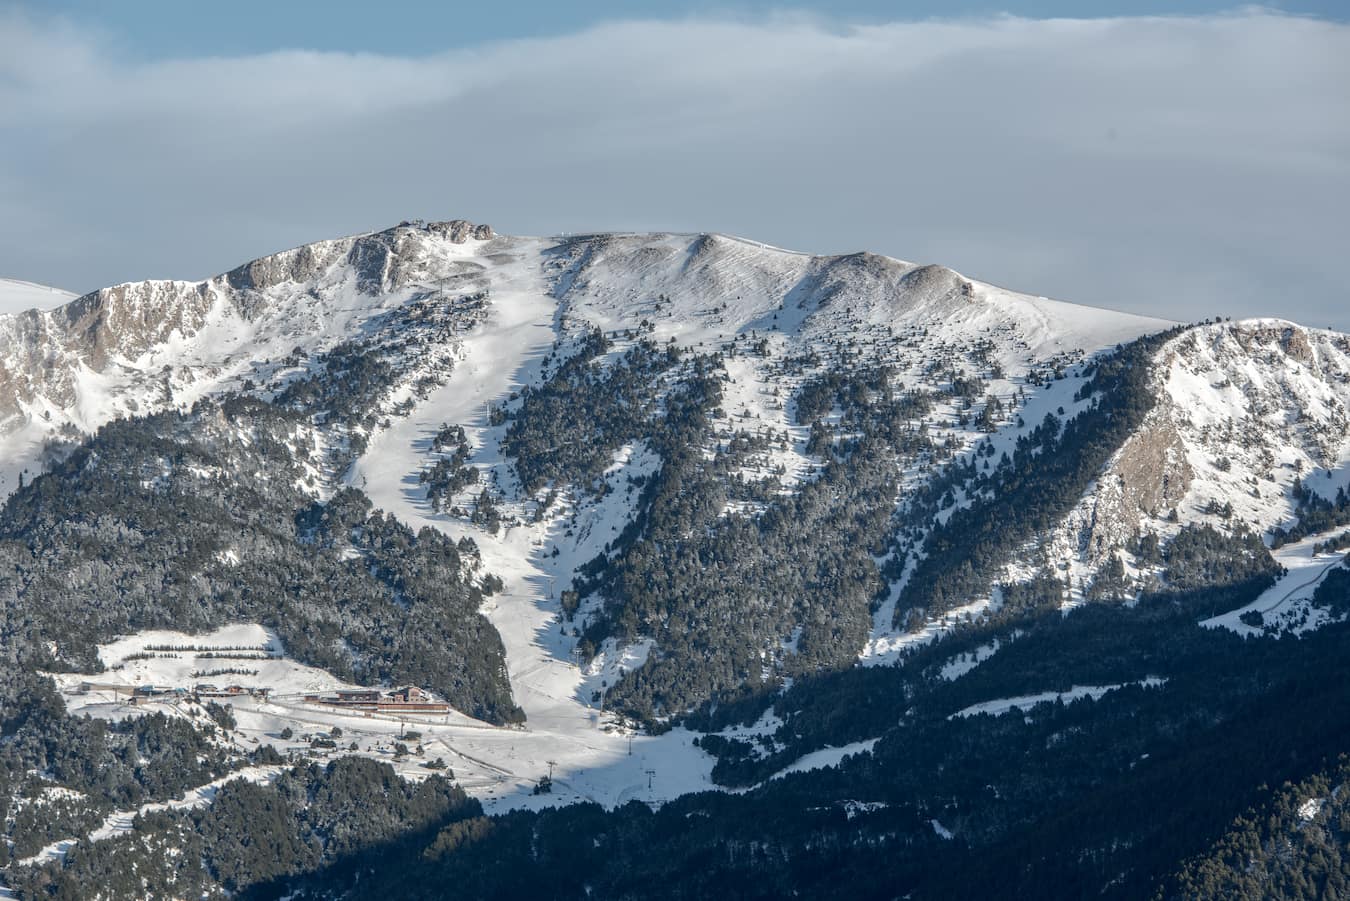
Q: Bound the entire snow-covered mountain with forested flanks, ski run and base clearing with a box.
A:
[10,220,1350,894]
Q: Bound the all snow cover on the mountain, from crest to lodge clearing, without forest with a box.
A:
[21,220,1350,893]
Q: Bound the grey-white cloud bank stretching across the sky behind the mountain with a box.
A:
[0,11,1350,330]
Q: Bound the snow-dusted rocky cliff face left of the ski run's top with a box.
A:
[0,220,491,493]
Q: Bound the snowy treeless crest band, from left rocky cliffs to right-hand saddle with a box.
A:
[0,220,1162,490]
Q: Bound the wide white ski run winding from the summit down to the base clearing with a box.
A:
[347,239,714,809]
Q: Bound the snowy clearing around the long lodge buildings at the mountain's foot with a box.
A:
[55,625,713,812]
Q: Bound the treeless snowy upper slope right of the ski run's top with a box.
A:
[551,235,1172,366]
